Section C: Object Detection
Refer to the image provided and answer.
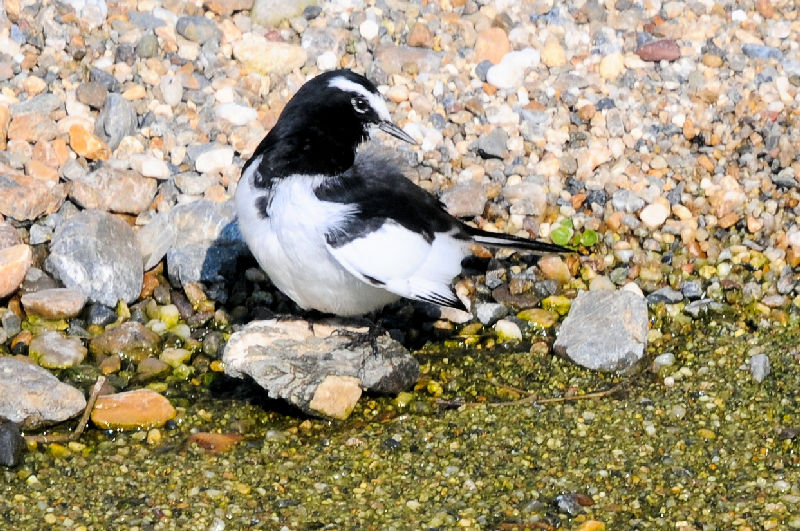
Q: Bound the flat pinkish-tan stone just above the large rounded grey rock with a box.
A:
[69,166,158,214]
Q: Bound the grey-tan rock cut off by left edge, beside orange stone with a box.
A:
[0,357,86,429]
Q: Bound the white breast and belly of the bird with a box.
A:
[236,166,400,316]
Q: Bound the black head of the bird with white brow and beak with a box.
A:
[245,69,415,182]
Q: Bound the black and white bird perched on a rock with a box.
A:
[236,70,569,316]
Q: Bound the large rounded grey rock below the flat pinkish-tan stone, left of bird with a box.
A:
[45,210,144,306]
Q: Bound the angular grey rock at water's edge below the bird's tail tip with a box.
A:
[554,290,648,372]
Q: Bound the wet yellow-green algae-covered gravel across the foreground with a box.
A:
[0,321,800,530]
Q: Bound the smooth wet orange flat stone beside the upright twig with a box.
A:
[92,389,176,430]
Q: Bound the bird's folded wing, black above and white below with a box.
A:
[315,150,469,308]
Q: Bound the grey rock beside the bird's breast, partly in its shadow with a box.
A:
[136,199,248,285]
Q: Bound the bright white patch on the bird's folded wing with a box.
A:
[328,222,467,306]
